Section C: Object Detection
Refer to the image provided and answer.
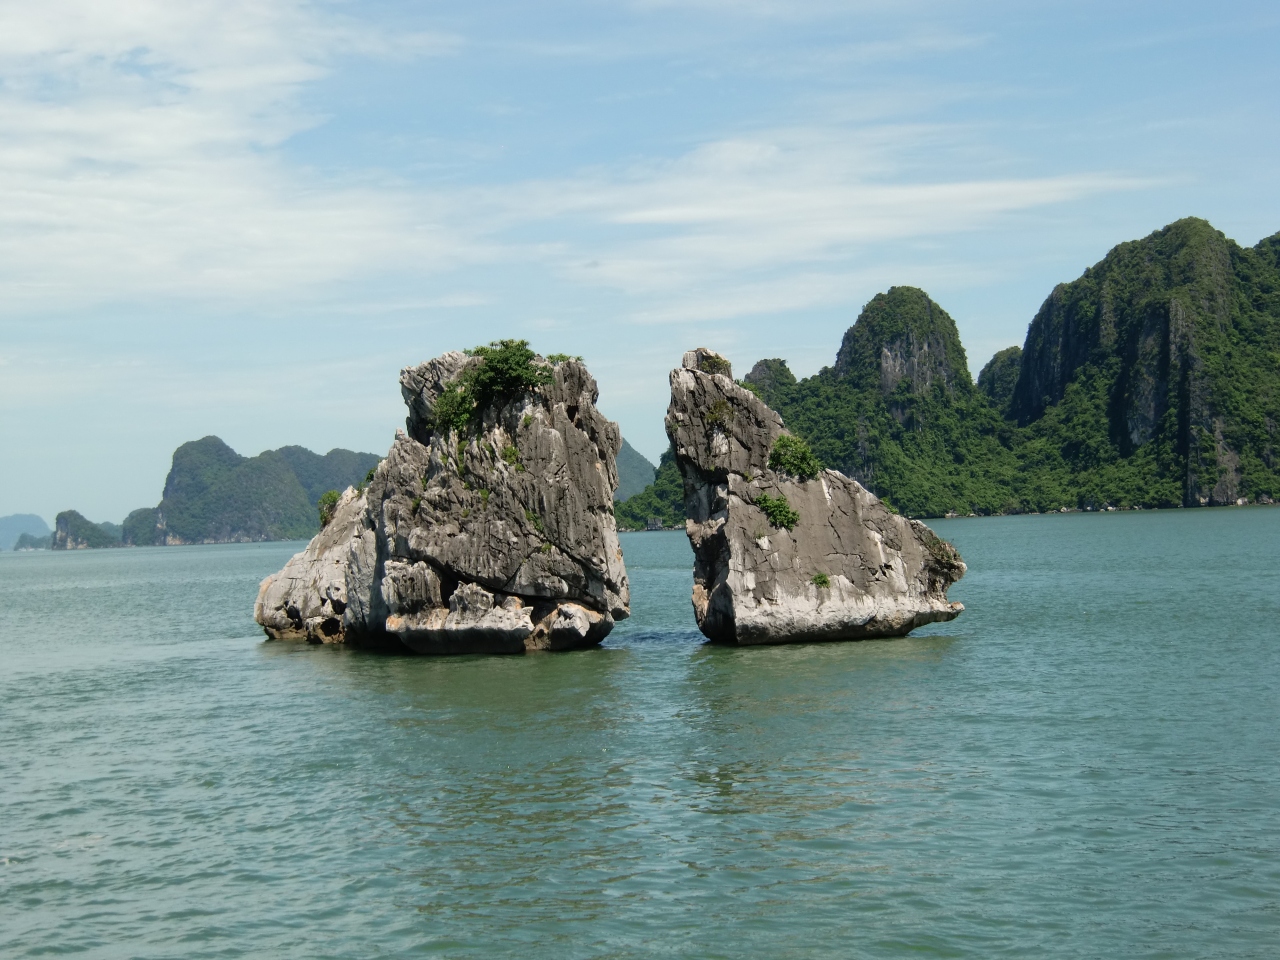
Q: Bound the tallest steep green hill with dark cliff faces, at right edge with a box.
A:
[1010,219,1280,506]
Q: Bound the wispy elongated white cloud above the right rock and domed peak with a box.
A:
[483,124,1146,316]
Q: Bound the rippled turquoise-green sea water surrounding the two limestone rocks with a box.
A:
[0,508,1280,959]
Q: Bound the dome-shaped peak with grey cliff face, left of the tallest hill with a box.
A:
[835,287,973,397]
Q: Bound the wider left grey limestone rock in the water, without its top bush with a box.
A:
[255,352,630,654]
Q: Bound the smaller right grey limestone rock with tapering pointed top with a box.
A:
[667,348,965,644]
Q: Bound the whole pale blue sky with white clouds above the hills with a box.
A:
[0,0,1280,522]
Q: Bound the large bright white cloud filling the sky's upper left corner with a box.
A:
[0,0,465,310]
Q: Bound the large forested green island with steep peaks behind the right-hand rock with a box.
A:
[617,219,1280,530]
